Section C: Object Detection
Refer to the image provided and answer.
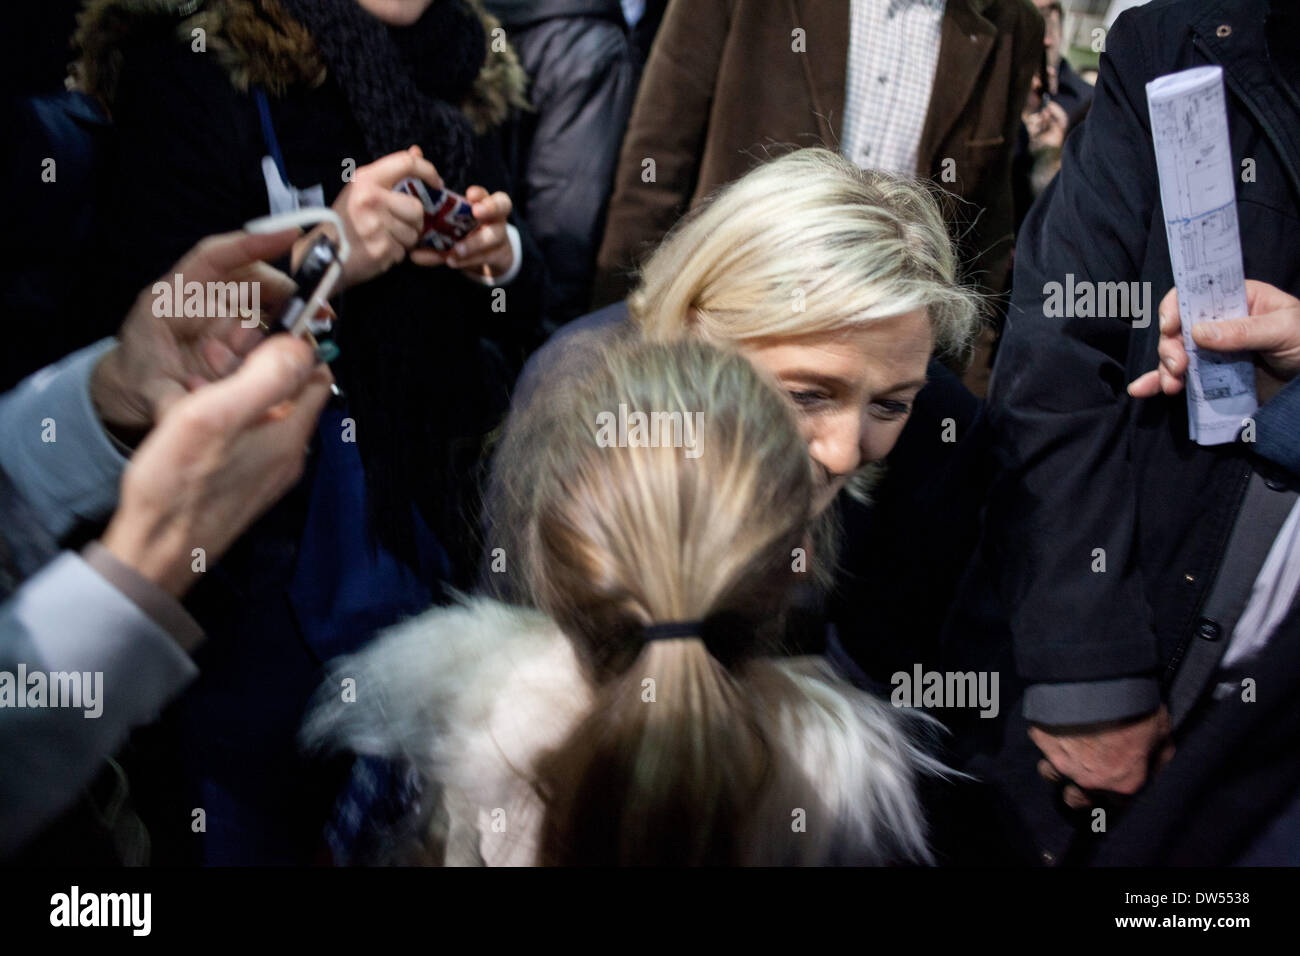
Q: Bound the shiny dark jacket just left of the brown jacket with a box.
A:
[486,0,641,325]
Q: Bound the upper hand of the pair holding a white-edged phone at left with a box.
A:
[90,229,299,431]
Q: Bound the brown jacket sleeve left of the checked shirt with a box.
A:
[593,0,732,306]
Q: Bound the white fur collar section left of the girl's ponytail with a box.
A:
[300,598,592,865]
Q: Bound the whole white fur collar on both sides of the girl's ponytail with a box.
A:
[302,598,950,865]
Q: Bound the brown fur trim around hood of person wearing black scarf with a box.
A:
[70,0,528,133]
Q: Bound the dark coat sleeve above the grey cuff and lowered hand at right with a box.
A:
[987,13,1158,702]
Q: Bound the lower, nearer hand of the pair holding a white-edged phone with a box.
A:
[103,336,332,597]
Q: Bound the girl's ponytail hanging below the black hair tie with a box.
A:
[537,637,770,866]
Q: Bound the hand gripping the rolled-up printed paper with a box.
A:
[1128,278,1300,405]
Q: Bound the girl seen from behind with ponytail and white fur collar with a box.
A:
[304,342,943,865]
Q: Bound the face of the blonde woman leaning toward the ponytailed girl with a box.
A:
[738,310,935,512]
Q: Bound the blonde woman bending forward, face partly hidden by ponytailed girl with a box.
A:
[482,148,980,682]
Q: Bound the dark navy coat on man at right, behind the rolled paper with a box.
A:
[948,0,1300,852]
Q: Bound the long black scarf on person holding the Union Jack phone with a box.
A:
[281,0,504,574]
